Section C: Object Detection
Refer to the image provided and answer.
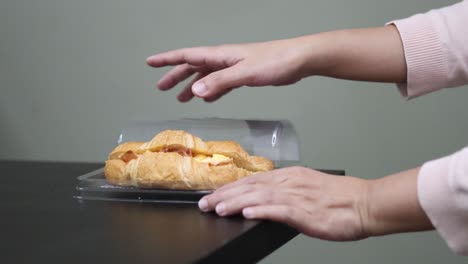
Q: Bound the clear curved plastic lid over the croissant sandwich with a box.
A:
[117,118,300,162]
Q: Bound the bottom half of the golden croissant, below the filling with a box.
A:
[105,152,253,190]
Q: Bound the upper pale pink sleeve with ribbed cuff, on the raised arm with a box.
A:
[391,1,468,99]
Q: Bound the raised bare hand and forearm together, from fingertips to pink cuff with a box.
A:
[147,26,406,102]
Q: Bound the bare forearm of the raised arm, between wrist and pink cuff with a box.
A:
[303,26,406,83]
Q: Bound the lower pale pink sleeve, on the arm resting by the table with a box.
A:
[418,147,468,255]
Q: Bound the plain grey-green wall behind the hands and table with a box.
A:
[0,0,468,263]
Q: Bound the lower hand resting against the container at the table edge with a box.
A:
[199,167,368,241]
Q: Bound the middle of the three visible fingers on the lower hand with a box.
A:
[215,188,274,216]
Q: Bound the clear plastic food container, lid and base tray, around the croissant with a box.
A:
[75,118,300,203]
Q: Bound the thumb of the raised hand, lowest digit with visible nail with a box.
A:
[192,66,248,98]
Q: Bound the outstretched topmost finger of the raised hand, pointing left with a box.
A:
[146,47,213,67]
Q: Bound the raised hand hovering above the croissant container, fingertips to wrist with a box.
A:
[147,38,314,102]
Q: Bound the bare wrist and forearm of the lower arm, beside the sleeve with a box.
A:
[365,168,433,236]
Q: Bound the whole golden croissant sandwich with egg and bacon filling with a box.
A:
[104,130,273,190]
